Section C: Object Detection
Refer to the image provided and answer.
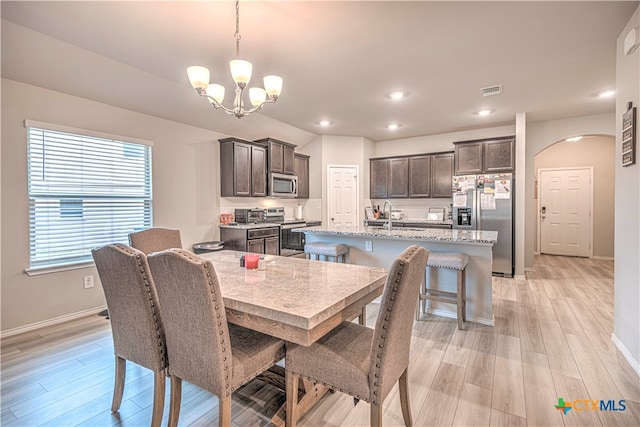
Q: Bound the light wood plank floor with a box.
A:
[0,256,640,427]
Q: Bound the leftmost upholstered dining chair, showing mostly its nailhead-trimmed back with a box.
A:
[91,244,168,426]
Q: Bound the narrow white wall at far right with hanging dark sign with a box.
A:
[612,7,640,374]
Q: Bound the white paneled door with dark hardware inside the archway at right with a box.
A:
[539,168,592,257]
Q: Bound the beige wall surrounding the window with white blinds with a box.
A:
[0,79,272,331]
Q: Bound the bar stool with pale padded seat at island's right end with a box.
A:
[416,251,469,329]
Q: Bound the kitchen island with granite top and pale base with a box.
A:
[293,226,498,326]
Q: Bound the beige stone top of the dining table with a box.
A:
[199,250,387,329]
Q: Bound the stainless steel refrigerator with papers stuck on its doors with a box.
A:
[452,173,515,277]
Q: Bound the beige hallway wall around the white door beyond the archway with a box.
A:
[533,136,616,259]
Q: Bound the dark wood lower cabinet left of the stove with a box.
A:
[220,226,280,255]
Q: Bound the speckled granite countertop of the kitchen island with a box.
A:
[293,225,498,245]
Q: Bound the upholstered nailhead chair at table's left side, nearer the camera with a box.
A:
[148,249,286,426]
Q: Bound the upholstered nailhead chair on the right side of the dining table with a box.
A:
[285,245,429,427]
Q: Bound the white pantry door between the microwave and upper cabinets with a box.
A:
[327,166,358,228]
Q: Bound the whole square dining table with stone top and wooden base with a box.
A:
[199,250,388,426]
